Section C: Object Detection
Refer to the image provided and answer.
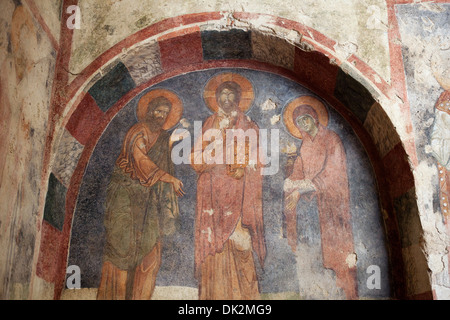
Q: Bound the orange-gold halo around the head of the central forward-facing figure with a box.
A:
[203,72,255,112]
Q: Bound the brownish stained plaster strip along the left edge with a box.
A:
[0,1,55,299]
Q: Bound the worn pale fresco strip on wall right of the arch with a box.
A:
[397,3,450,297]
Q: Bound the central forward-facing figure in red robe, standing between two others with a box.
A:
[191,81,266,300]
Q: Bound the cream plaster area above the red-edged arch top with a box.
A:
[70,0,390,81]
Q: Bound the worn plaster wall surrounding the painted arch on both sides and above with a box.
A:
[0,0,450,299]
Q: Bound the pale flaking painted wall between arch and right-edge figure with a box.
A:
[398,3,450,299]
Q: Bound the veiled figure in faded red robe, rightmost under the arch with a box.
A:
[284,105,358,299]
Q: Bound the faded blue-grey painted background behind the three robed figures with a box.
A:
[63,69,389,299]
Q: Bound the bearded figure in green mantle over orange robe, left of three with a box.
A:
[97,97,184,300]
